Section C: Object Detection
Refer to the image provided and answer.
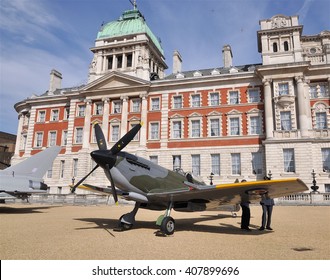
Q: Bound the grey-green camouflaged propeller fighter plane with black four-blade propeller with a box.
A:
[71,124,308,235]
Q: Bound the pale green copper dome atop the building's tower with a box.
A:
[97,10,164,55]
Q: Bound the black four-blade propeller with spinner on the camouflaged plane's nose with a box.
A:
[71,123,142,201]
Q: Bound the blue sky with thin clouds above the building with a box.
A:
[0,0,330,134]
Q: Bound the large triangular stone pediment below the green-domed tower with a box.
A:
[83,72,150,92]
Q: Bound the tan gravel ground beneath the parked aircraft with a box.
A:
[0,204,330,260]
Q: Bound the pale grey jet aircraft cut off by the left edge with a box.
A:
[0,146,61,202]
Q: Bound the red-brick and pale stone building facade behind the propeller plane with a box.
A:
[14,12,330,193]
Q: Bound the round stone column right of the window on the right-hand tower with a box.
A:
[295,76,309,137]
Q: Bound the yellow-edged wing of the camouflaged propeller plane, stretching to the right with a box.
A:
[147,178,308,205]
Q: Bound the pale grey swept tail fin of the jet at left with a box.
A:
[3,146,61,178]
